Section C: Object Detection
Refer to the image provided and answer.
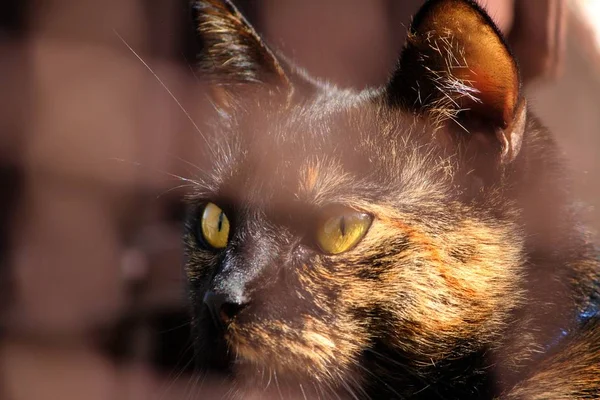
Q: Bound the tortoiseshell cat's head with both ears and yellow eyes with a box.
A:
[185,0,526,394]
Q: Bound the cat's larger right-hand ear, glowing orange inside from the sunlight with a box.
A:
[386,0,527,164]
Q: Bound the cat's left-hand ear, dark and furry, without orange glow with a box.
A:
[192,0,290,101]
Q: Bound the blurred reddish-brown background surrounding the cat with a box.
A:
[0,0,600,400]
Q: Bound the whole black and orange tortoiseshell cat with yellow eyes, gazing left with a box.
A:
[184,0,600,400]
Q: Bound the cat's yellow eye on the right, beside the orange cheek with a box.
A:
[317,207,372,254]
